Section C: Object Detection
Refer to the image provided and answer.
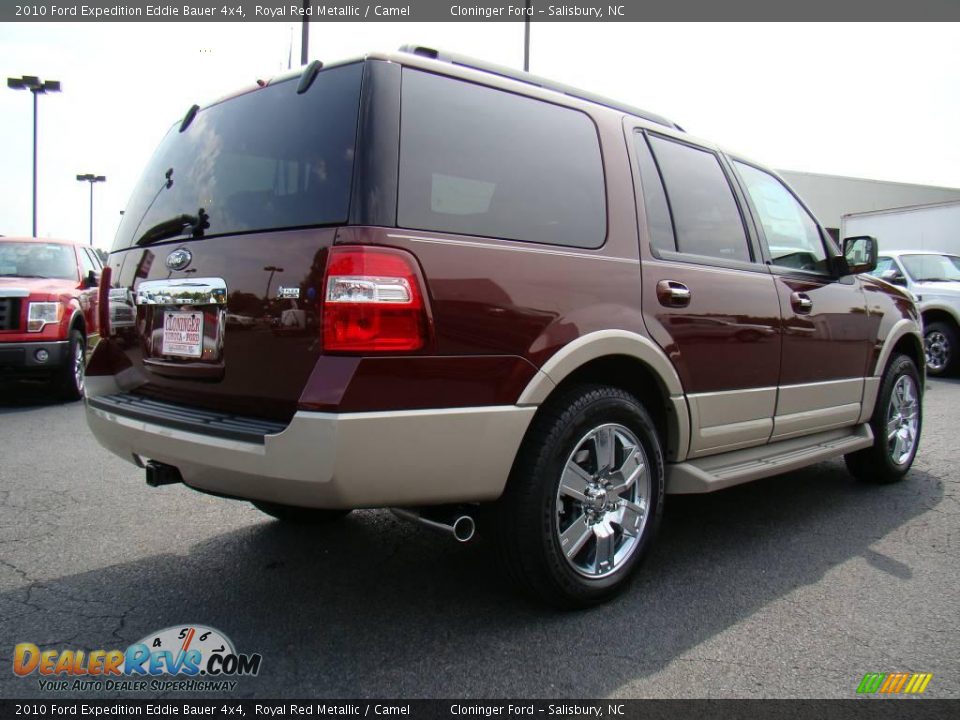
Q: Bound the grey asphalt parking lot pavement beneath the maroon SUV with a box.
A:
[0,380,960,699]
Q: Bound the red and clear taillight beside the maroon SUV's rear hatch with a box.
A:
[323,246,428,353]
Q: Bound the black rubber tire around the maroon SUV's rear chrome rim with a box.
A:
[537,388,664,601]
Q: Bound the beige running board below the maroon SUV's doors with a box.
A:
[667,423,873,495]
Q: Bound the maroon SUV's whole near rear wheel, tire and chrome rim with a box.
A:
[491,386,664,608]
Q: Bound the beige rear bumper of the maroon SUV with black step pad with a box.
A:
[86,378,536,508]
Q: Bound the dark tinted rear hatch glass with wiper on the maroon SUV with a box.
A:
[114,63,363,250]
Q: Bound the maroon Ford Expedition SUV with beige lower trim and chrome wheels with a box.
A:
[87,48,924,606]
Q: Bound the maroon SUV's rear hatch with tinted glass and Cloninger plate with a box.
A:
[100,62,363,422]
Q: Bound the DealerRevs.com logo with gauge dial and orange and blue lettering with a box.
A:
[13,625,263,692]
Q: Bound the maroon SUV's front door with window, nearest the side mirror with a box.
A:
[733,160,876,440]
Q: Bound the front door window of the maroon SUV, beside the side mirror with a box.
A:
[734,161,830,274]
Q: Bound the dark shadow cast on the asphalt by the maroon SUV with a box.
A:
[0,462,943,698]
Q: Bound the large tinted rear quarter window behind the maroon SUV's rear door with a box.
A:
[397,69,607,248]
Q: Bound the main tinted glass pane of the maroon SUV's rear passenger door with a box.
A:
[641,135,750,262]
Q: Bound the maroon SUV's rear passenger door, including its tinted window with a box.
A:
[630,128,780,457]
